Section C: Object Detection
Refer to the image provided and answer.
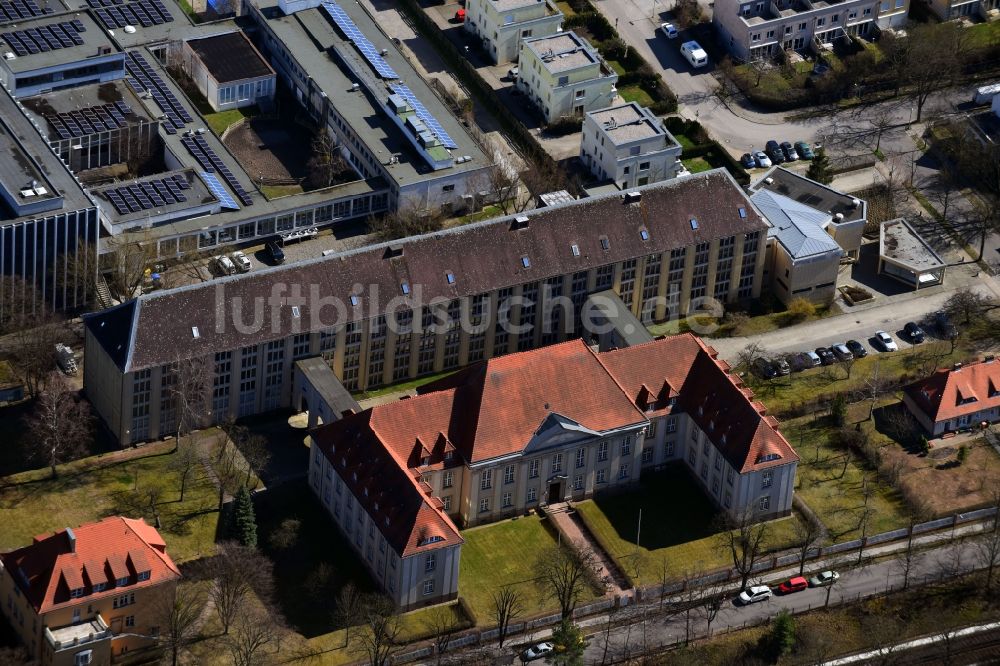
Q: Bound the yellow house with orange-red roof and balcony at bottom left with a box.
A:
[0,516,181,666]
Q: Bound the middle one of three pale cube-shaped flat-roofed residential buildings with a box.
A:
[517,32,618,123]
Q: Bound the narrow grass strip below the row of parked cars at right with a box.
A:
[746,341,972,416]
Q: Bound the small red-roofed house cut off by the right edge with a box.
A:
[903,356,1000,436]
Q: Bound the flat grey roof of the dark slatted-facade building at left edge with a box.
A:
[0,82,93,225]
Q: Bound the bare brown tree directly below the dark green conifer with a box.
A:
[207,542,274,635]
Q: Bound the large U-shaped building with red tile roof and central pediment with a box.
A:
[309,334,798,608]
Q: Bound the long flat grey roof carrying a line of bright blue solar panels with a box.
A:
[259,0,490,187]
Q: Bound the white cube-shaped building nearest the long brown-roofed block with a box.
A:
[580,102,682,190]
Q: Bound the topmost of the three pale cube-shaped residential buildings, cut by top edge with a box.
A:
[465,0,563,65]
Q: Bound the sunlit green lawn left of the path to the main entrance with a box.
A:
[458,514,596,626]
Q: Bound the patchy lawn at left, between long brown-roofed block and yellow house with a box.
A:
[0,442,218,562]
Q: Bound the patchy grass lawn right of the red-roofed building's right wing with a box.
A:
[782,405,908,542]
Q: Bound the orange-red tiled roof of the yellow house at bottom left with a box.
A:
[0,516,180,613]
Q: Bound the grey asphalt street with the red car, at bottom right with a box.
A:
[584,542,977,664]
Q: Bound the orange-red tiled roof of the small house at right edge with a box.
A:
[903,361,1000,422]
